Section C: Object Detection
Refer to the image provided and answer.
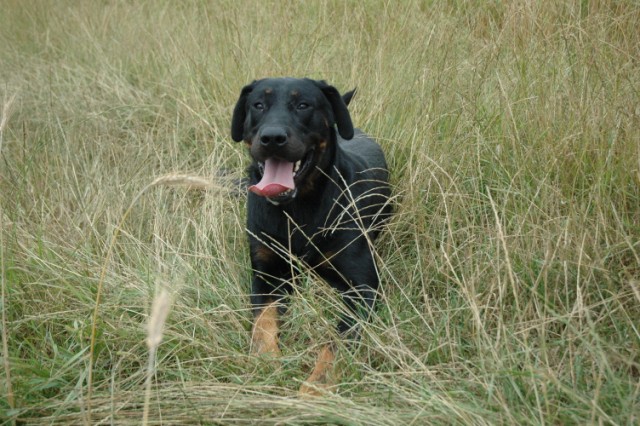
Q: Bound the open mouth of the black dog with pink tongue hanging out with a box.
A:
[249,150,313,201]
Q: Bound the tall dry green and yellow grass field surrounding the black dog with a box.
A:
[0,0,640,425]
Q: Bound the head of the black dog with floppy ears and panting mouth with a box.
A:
[231,78,354,204]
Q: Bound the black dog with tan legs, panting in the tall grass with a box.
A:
[231,78,391,393]
